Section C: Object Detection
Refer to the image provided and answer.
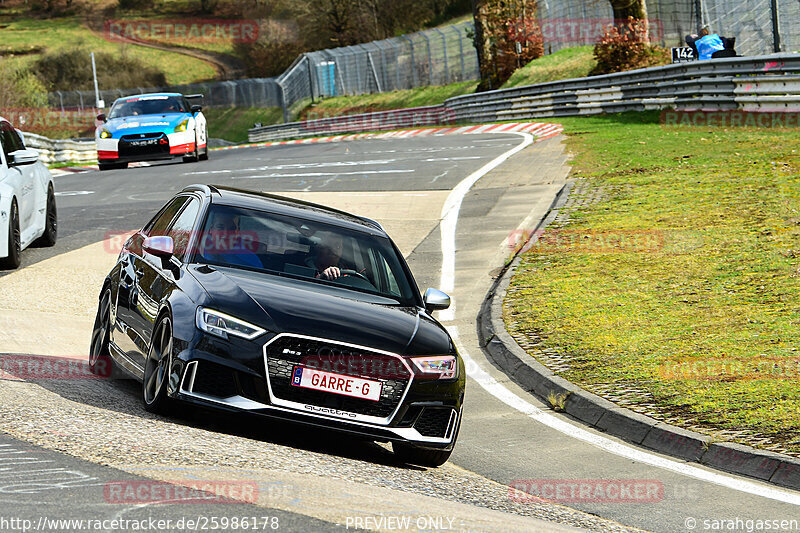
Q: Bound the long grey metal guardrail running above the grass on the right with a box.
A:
[249,54,800,142]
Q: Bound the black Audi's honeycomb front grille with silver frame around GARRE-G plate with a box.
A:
[265,336,411,418]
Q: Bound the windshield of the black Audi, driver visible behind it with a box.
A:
[194,204,419,306]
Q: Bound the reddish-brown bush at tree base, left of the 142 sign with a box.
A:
[589,17,669,76]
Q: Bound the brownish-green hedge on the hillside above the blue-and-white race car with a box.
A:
[31,48,167,91]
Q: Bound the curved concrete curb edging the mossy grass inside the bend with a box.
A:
[478,181,800,490]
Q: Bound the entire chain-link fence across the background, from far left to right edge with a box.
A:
[50,4,800,121]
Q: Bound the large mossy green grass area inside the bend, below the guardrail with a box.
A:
[504,113,800,452]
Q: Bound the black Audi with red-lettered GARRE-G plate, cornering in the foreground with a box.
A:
[89,185,466,466]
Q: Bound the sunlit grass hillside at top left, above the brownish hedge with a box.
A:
[2,17,216,84]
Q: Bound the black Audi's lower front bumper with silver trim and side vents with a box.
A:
[175,334,465,449]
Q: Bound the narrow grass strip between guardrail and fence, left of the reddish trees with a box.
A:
[300,81,477,119]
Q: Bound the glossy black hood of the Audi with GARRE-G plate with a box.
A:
[190,266,452,355]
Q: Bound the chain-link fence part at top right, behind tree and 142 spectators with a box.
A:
[538,0,800,56]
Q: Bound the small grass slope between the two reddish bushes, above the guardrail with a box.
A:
[503,46,596,88]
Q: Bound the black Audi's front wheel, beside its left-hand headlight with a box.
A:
[142,315,173,414]
